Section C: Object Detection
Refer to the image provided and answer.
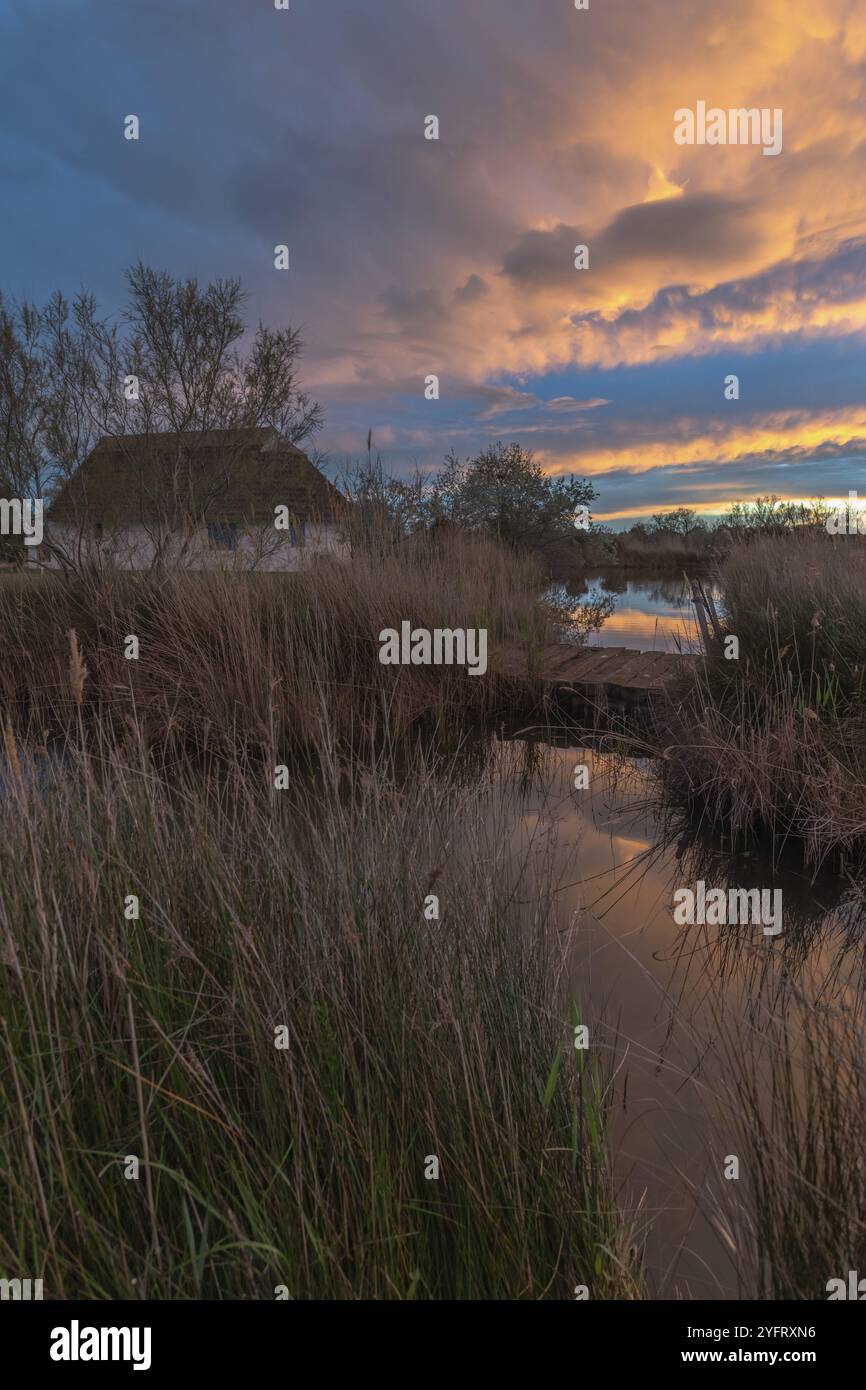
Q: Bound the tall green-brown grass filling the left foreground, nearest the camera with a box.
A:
[0,708,638,1300]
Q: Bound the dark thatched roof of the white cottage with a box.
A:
[47,430,346,527]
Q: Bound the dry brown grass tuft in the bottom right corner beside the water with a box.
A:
[695,931,866,1300]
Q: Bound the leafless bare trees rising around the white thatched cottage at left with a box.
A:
[0,263,321,570]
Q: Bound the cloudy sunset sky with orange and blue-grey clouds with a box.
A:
[0,0,866,527]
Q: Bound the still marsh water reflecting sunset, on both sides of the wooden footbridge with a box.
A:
[498,573,866,1298]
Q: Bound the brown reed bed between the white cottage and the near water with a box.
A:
[0,537,583,760]
